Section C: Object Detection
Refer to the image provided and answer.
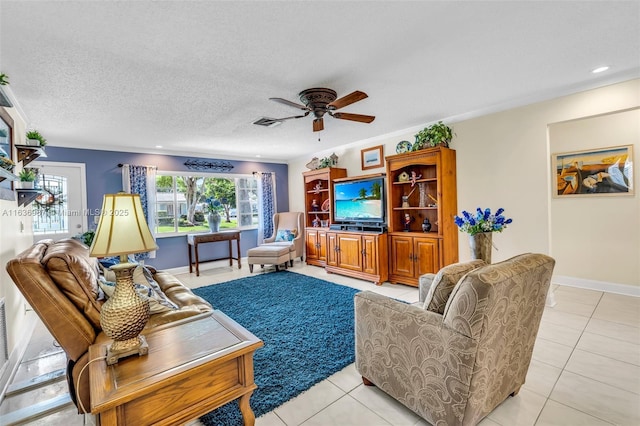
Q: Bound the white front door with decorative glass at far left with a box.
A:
[31,161,88,242]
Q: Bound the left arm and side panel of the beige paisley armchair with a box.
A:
[354,291,477,424]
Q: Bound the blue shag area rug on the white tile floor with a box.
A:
[193,271,358,426]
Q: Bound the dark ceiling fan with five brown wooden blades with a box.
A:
[254,87,375,132]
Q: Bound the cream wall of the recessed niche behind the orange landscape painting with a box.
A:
[549,109,640,285]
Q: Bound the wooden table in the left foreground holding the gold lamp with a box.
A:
[89,311,263,426]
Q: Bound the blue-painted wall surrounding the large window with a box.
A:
[38,146,289,269]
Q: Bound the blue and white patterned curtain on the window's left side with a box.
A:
[122,164,156,261]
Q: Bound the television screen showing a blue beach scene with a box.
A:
[335,180,384,219]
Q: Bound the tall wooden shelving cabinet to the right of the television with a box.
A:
[386,147,458,286]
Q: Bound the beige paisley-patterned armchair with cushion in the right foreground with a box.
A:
[355,253,555,426]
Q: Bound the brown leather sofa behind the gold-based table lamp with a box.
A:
[7,239,213,413]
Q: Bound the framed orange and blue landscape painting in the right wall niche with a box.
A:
[551,145,633,198]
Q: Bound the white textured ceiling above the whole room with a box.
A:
[0,0,640,161]
